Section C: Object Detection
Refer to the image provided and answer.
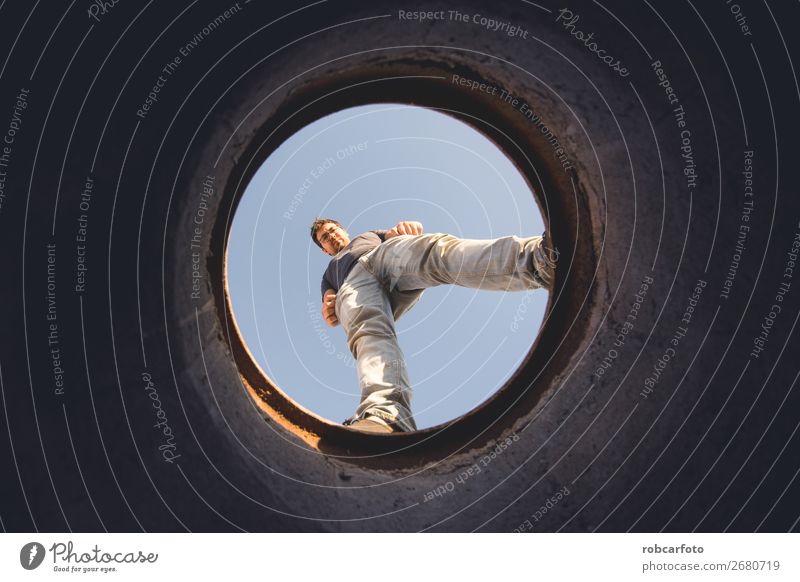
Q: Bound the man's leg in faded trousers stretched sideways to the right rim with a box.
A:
[362,233,554,292]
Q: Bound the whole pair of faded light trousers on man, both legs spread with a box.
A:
[336,234,554,431]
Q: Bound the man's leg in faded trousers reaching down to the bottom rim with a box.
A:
[336,264,416,431]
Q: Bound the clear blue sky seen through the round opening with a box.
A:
[227,104,547,428]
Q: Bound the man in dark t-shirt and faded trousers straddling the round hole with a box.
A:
[311,218,557,433]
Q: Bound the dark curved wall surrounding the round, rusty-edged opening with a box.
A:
[0,2,798,531]
